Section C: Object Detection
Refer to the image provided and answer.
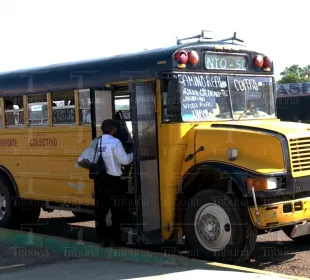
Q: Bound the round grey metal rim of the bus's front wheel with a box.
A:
[194,203,231,252]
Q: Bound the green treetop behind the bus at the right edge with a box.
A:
[278,64,310,84]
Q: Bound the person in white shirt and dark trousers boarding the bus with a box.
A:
[95,119,133,246]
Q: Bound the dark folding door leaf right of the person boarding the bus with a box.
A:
[129,82,161,244]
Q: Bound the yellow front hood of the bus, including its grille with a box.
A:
[184,119,310,177]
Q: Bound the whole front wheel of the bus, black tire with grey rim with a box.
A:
[184,189,257,264]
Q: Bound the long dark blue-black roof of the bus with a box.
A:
[0,41,258,96]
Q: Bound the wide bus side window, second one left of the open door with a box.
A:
[52,90,75,125]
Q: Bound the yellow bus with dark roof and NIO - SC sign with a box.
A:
[0,31,310,262]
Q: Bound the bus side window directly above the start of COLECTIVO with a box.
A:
[27,94,48,127]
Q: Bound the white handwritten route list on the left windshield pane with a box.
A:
[178,74,229,119]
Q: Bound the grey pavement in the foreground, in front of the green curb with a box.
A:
[0,244,294,280]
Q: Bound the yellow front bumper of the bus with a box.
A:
[248,197,310,233]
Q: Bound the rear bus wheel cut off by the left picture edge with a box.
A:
[0,175,21,229]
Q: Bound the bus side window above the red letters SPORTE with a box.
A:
[4,96,25,127]
